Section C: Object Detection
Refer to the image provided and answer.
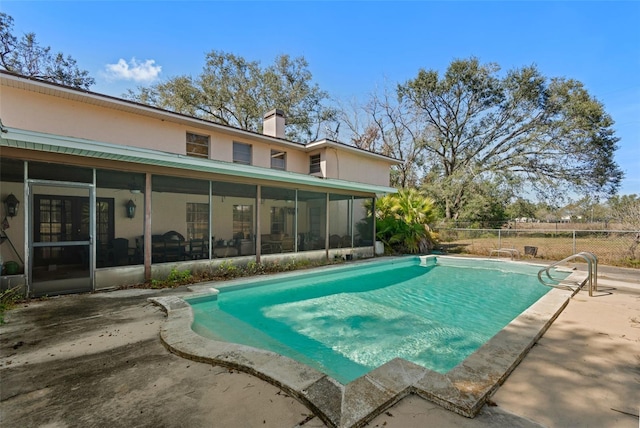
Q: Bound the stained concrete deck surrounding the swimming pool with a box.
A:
[0,267,640,427]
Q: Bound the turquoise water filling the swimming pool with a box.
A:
[190,257,568,384]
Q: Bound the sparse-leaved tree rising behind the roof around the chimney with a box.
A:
[125,51,335,141]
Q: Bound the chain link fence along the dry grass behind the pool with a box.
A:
[432,228,640,268]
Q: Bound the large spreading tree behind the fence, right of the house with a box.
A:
[342,58,623,220]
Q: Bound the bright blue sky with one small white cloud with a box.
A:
[5,0,640,195]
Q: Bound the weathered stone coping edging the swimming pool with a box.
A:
[149,256,587,428]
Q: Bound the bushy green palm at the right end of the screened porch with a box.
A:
[376,188,435,253]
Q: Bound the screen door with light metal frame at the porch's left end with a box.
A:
[29,182,96,297]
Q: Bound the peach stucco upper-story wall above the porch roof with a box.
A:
[0,86,393,186]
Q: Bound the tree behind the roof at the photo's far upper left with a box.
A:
[0,13,95,89]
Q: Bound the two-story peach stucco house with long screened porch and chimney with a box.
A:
[0,72,399,296]
